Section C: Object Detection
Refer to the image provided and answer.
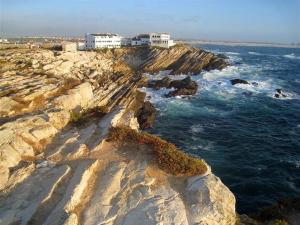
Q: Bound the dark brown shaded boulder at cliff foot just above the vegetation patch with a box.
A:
[136,101,156,129]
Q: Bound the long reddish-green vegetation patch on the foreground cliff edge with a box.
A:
[108,127,207,176]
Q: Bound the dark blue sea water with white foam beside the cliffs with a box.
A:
[142,45,300,213]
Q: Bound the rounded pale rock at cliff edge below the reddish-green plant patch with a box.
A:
[186,174,236,225]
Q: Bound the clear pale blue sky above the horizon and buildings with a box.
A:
[0,0,300,43]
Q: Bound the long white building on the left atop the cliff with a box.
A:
[85,33,122,49]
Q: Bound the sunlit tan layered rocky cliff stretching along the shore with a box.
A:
[0,46,235,225]
